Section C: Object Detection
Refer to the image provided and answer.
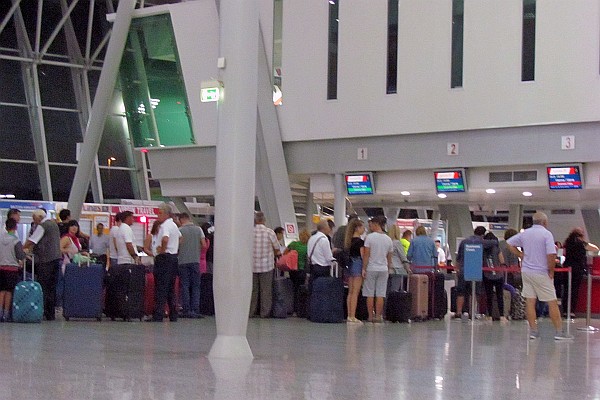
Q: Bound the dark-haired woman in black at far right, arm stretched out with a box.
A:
[562,228,598,313]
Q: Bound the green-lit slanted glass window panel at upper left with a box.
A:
[120,14,195,147]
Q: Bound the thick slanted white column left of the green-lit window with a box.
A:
[69,0,136,219]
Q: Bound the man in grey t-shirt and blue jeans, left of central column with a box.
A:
[177,213,206,318]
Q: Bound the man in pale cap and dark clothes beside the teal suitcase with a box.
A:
[23,209,62,321]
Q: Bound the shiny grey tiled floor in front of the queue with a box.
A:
[0,318,600,400]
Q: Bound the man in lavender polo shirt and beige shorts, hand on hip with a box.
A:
[506,212,573,340]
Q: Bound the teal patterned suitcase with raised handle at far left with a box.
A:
[12,256,44,322]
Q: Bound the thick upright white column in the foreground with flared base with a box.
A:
[208,0,259,359]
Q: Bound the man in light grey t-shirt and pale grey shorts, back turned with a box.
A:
[362,215,394,323]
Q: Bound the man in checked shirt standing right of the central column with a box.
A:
[250,212,281,318]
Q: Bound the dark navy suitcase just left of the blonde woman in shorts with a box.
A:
[309,263,345,323]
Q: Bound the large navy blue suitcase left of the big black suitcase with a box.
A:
[63,264,104,321]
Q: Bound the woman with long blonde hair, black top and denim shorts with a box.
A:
[344,218,365,324]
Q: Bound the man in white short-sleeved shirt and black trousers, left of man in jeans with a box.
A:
[148,203,181,322]
